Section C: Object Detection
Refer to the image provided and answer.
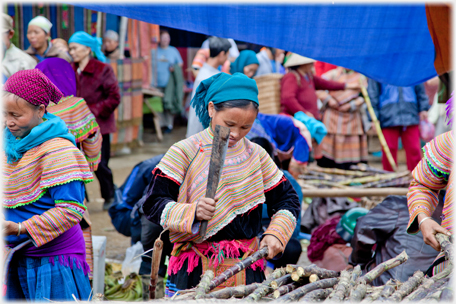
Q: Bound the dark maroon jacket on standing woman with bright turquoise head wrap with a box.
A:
[71,58,120,135]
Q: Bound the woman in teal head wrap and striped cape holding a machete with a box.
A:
[142,73,300,297]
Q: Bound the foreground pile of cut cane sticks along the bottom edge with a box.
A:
[172,234,453,303]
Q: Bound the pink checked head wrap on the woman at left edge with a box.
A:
[3,69,63,107]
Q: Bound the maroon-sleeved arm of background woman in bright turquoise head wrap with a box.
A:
[91,64,120,118]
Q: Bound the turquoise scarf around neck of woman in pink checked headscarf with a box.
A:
[3,113,76,164]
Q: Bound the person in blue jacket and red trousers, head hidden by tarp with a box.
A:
[367,79,430,171]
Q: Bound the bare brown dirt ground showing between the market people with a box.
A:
[87,127,405,265]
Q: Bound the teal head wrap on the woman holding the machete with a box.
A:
[190,73,259,128]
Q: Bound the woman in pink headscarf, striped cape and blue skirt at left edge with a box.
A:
[2,69,93,301]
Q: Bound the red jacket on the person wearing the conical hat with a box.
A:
[280,72,345,119]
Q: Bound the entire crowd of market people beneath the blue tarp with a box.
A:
[1,14,453,301]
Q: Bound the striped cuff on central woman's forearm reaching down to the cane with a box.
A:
[264,209,296,246]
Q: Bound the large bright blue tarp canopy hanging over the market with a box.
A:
[71,3,437,86]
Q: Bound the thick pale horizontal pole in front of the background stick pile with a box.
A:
[302,188,408,197]
